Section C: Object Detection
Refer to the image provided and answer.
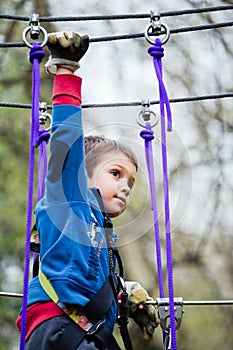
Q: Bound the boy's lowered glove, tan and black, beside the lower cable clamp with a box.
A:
[126,282,159,340]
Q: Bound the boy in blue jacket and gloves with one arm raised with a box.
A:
[17,33,158,350]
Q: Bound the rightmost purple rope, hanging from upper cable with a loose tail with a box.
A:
[148,39,176,350]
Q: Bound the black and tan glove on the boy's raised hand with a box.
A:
[45,32,89,75]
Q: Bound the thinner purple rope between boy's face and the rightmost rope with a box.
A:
[140,122,164,298]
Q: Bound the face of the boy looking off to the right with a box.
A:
[88,151,136,218]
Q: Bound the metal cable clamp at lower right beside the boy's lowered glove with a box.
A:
[156,297,184,332]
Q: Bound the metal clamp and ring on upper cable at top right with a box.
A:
[144,11,170,44]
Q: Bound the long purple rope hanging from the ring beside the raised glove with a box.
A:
[20,43,44,350]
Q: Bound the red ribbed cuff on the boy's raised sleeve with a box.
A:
[53,74,82,106]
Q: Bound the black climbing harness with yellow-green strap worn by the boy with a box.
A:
[31,188,133,350]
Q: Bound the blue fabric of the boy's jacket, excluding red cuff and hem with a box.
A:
[28,105,116,331]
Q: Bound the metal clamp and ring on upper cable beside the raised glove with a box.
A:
[22,13,48,48]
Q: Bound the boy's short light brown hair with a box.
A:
[84,135,138,177]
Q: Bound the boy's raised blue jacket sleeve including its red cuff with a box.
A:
[46,74,87,204]
